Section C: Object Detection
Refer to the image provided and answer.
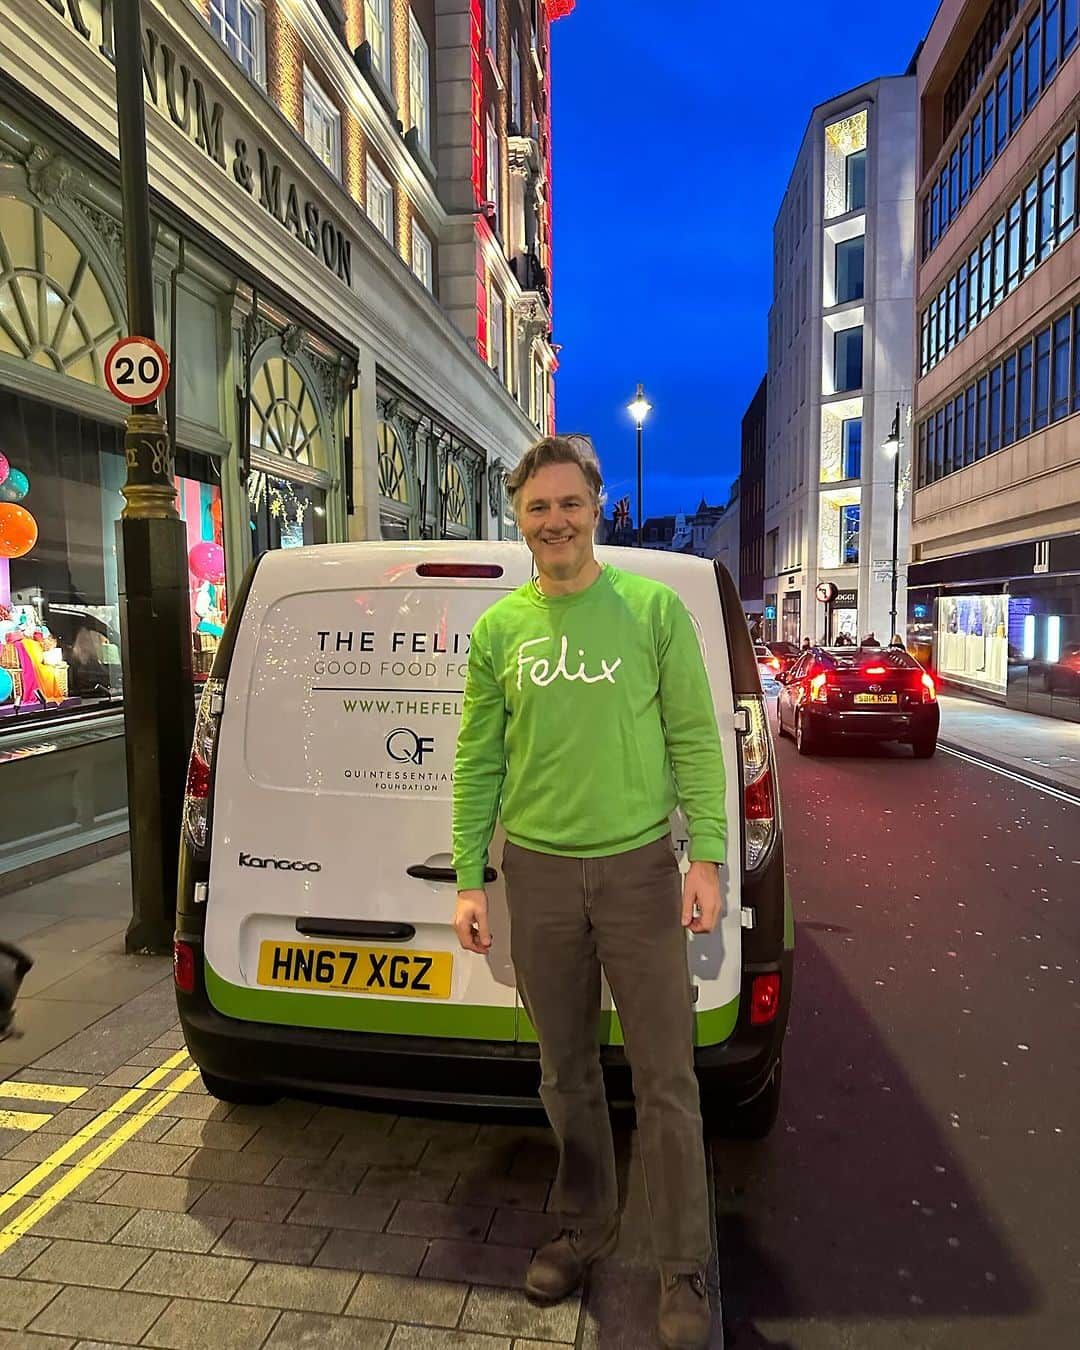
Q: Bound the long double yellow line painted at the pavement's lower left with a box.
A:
[0,1049,198,1256]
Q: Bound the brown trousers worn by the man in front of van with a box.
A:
[502,836,711,1270]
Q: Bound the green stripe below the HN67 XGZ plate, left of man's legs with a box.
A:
[204,961,517,1041]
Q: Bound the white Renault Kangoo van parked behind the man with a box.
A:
[176,541,794,1134]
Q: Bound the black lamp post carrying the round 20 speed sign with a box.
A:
[112,0,194,953]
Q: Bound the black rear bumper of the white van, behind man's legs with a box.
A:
[177,952,792,1108]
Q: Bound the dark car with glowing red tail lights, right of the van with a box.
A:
[776,647,941,759]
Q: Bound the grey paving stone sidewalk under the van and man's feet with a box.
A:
[0,859,722,1350]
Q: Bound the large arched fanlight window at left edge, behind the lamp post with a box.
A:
[0,197,122,389]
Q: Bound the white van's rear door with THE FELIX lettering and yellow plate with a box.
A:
[205,543,529,1041]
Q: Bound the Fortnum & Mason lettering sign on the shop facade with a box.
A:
[41,0,352,288]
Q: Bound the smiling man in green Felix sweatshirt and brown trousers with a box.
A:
[454,437,726,1350]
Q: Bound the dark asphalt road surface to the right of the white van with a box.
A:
[716,712,1080,1350]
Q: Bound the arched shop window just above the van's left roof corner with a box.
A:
[247,354,329,554]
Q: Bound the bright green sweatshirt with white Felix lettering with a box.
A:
[454,567,728,890]
